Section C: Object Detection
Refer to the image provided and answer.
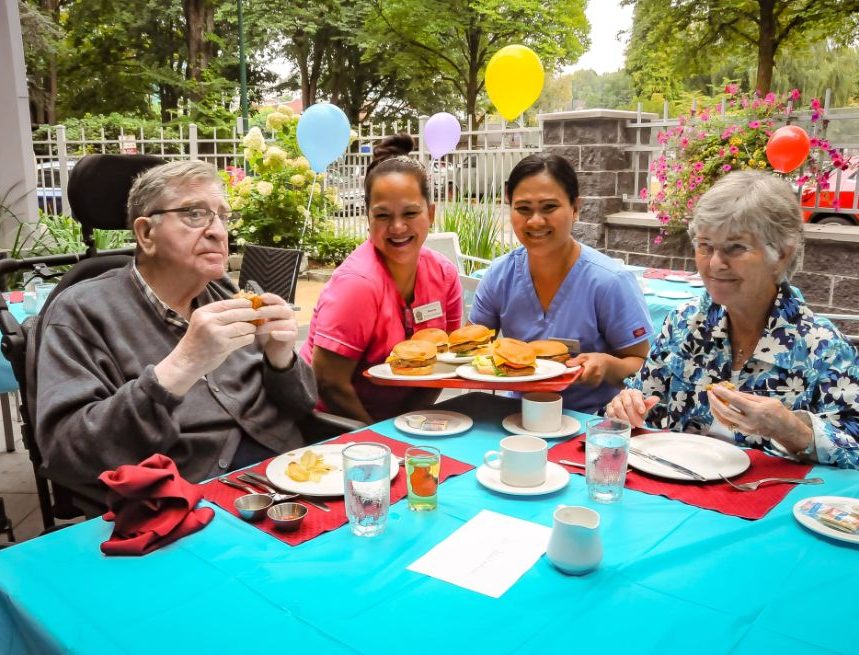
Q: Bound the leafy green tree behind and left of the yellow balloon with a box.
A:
[361,0,589,125]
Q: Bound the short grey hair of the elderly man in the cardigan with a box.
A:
[128,159,224,229]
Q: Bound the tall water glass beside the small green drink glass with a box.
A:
[343,443,391,537]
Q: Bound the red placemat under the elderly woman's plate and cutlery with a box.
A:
[549,435,812,520]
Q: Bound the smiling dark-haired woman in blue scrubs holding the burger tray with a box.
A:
[469,153,653,413]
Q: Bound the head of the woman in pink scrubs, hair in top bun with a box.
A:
[364,134,435,268]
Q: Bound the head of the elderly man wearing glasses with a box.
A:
[128,160,231,285]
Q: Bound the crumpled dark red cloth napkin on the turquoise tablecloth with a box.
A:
[98,454,215,555]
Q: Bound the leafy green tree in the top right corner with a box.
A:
[624,0,859,96]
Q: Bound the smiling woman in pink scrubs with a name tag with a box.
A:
[301,134,462,423]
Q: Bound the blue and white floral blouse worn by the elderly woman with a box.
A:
[627,283,859,469]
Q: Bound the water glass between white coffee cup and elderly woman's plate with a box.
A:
[585,418,630,503]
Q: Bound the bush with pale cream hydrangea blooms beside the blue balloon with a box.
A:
[226,106,339,248]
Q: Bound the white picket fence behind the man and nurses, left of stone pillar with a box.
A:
[34,118,543,245]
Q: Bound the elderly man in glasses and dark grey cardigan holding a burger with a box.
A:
[36,161,316,498]
